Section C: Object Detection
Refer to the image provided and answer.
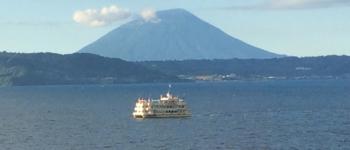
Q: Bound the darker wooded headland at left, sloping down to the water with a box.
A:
[0,52,179,85]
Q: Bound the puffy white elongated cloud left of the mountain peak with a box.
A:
[73,5,131,27]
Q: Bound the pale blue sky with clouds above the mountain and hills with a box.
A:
[0,0,350,57]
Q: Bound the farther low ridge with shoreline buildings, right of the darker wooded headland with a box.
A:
[140,56,350,79]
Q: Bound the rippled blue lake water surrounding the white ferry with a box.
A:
[0,80,350,150]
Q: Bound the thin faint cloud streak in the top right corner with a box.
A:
[231,0,350,9]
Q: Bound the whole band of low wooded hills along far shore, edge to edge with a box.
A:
[0,52,350,85]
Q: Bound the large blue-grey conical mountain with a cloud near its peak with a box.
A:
[79,9,281,61]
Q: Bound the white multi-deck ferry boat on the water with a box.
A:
[132,86,191,118]
